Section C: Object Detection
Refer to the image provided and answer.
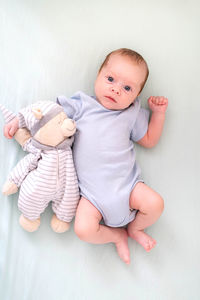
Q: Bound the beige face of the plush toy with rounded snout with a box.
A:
[34,112,76,146]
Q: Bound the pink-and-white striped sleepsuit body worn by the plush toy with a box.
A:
[9,147,80,222]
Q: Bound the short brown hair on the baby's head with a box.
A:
[99,48,149,92]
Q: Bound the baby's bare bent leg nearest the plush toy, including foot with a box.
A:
[74,197,130,264]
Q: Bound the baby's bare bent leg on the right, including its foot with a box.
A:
[127,182,164,251]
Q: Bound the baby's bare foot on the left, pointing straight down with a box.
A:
[115,229,130,264]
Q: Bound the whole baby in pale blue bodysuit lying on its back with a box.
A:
[4,48,168,264]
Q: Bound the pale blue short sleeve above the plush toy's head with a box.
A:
[56,93,82,121]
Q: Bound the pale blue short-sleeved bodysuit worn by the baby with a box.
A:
[57,92,149,227]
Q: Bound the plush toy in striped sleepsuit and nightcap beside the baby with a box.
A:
[0,101,80,233]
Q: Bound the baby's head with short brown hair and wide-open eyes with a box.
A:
[95,48,149,110]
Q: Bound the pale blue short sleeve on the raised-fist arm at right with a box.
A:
[131,108,149,142]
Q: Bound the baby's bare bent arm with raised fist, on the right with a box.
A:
[138,96,168,148]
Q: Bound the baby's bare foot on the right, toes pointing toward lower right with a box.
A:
[129,230,156,252]
